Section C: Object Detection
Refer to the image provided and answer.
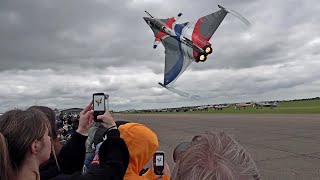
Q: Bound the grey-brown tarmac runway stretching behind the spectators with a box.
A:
[114,114,320,180]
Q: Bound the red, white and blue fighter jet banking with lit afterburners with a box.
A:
[143,5,250,90]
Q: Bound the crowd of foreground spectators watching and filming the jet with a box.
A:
[0,100,260,180]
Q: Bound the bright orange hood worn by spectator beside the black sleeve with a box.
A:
[119,123,159,180]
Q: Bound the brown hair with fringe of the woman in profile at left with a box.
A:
[0,109,51,180]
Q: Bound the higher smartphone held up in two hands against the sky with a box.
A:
[92,93,106,122]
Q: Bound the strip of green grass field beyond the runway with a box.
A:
[129,99,320,114]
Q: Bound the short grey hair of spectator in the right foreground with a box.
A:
[171,130,260,180]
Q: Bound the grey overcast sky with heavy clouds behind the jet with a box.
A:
[0,0,320,112]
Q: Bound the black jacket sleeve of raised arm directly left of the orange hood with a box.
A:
[48,129,129,180]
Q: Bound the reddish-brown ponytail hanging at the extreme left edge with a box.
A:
[0,133,14,180]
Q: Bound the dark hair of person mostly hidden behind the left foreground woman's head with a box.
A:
[28,106,58,139]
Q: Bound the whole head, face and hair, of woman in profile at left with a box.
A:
[0,109,51,180]
